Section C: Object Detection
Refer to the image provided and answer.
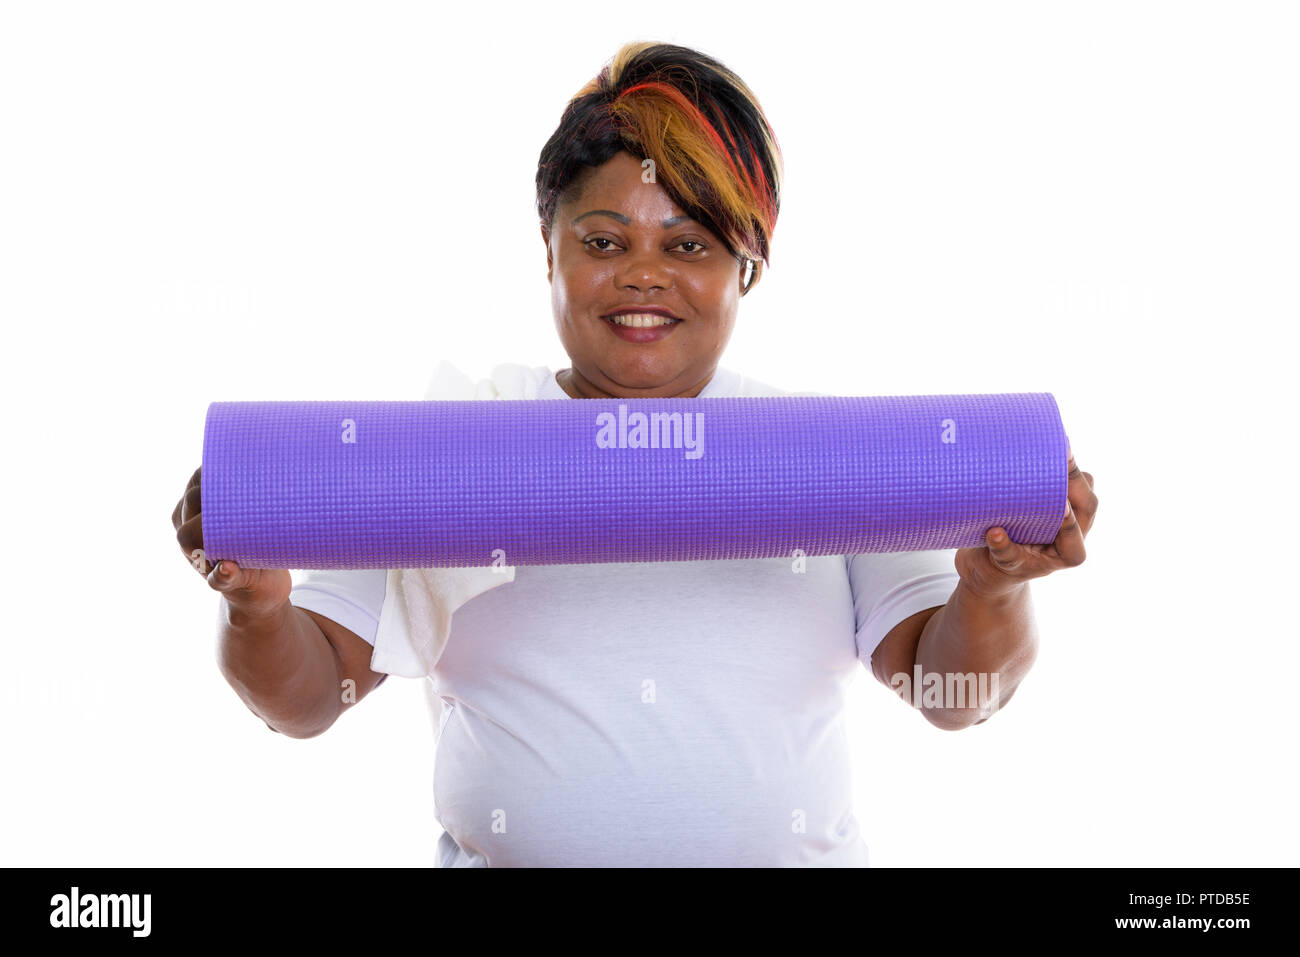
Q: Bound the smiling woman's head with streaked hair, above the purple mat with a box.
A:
[537,43,781,398]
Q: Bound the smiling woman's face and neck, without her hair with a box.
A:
[542,152,741,398]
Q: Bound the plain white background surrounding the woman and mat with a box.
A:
[0,3,1300,866]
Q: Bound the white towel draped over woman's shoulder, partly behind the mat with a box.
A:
[371,361,551,677]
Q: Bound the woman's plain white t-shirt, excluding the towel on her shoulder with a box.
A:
[290,367,958,867]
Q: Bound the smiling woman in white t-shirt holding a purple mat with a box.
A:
[173,43,1097,866]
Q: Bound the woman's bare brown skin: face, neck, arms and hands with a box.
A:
[172,152,1097,737]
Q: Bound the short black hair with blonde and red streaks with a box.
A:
[537,43,783,289]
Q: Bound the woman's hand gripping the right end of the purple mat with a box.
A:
[956,451,1097,598]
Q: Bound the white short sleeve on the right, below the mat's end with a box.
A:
[845,549,961,668]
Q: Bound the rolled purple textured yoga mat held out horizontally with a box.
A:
[202,393,1069,568]
